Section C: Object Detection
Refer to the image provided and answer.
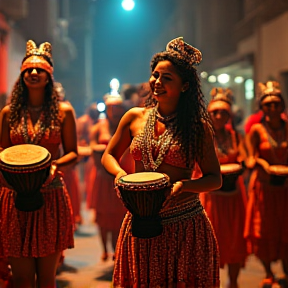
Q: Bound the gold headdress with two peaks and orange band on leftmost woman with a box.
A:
[21,40,53,78]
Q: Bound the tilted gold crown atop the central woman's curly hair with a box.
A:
[166,37,202,65]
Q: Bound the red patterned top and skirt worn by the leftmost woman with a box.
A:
[0,112,74,257]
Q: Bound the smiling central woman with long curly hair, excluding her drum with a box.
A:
[102,37,221,288]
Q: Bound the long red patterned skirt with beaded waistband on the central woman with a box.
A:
[113,199,220,288]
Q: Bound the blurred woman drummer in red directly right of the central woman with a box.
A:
[200,87,247,288]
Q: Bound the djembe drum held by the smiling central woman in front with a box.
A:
[116,172,170,238]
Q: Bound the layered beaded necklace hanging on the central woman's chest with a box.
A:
[141,106,176,171]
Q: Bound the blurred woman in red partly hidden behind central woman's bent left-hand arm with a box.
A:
[89,94,126,261]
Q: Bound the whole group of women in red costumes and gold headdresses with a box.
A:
[0,37,288,288]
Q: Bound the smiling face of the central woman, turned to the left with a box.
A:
[149,60,188,105]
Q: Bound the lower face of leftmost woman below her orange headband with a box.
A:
[23,68,49,88]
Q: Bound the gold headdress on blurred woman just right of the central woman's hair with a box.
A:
[208,87,233,113]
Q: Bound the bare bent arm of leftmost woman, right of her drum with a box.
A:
[55,102,78,170]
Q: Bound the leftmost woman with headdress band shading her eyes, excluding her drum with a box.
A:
[0,40,77,288]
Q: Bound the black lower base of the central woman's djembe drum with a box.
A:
[132,215,163,239]
